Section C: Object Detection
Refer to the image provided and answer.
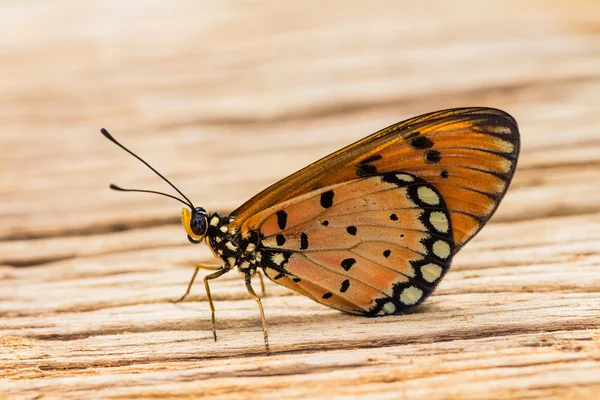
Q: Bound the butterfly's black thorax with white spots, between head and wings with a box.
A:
[206,213,261,276]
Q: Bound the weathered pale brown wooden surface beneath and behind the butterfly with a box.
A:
[0,0,600,399]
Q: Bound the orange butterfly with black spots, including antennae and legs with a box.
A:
[101,107,520,354]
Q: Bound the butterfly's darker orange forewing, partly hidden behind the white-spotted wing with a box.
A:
[230,108,520,252]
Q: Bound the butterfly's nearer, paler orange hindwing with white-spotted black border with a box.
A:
[242,172,454,316]
